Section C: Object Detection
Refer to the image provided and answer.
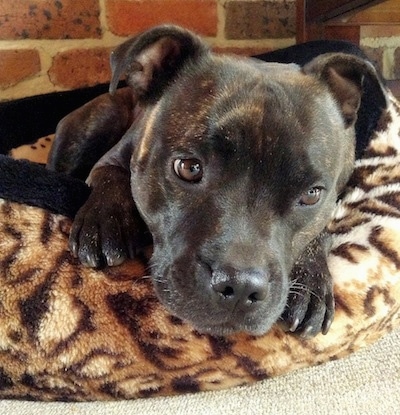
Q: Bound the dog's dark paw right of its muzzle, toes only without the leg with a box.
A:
[281,264,335,338]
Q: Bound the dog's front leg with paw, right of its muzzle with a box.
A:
[281,231,335,337]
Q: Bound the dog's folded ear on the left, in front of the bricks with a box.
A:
[110,25,208,99]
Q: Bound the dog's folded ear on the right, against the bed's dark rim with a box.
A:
[303,53,385,127]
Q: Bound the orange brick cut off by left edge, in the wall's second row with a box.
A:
[0,49,40,89]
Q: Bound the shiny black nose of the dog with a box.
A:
[211,266,268,307]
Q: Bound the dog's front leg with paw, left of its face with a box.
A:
[70,138,151,267]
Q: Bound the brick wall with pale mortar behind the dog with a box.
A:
[0,0,400,100]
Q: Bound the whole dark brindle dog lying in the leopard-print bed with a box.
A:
[48,25,384,337]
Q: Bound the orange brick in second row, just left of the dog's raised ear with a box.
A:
[49,48,111,89]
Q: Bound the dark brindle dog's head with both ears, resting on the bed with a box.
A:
[111,26,379,334]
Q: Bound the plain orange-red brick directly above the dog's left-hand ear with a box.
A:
[106,0,218,36]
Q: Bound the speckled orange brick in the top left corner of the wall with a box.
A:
[0,0,101,39]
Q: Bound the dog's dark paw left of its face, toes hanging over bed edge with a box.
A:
[69,194,148,268]
